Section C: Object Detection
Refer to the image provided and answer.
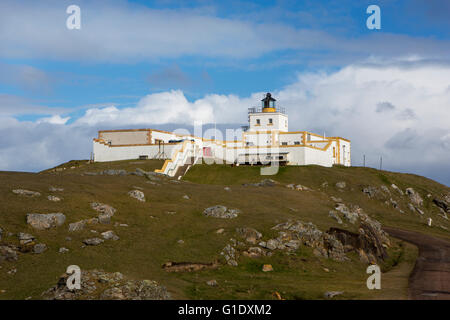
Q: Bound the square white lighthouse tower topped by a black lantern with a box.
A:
[248,93,288,132]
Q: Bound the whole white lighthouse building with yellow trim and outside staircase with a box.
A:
[93,93,351,176]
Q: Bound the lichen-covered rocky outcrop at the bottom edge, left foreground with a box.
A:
[42,270,171,300]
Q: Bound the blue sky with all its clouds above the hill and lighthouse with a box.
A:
[0,0,450,186]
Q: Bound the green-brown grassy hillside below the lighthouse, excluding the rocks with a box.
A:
[0,160,450,299]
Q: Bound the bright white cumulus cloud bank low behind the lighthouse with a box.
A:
[0,61,450,185]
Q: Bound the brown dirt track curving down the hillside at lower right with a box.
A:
[384,227,450,300]
